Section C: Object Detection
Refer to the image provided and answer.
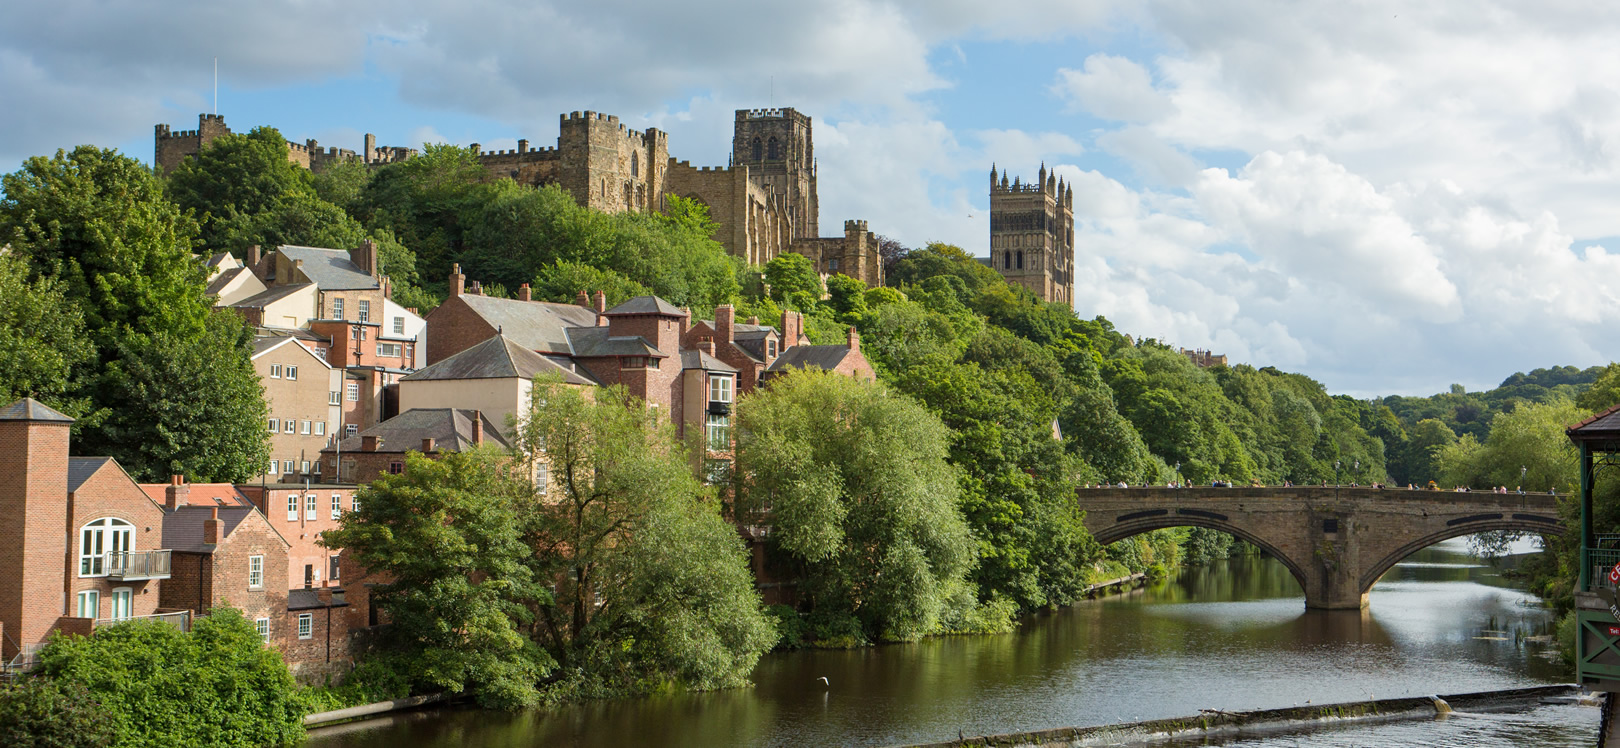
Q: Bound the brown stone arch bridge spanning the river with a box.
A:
[1076,486,1563,610]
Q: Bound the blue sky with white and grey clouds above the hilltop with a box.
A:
[0,0,1620,397]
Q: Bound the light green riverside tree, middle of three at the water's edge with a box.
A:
[520,379,776,695]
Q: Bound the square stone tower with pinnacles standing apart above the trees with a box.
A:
[990,164,1074,306]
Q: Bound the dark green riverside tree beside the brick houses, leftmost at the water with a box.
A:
[322,448,554,709]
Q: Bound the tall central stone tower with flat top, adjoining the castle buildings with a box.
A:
[731,108,821,238]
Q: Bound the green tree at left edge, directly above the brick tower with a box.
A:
[0,251,96,416]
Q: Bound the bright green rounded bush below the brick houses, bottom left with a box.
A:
[34,607,305,748]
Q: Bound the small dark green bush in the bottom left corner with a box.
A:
[0,677,118,748]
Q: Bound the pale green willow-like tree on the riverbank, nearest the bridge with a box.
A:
[737,371,974,641]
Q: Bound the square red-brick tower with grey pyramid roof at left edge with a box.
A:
[0,398,73,659]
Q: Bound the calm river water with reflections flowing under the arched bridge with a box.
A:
[308,539,1599,748]
